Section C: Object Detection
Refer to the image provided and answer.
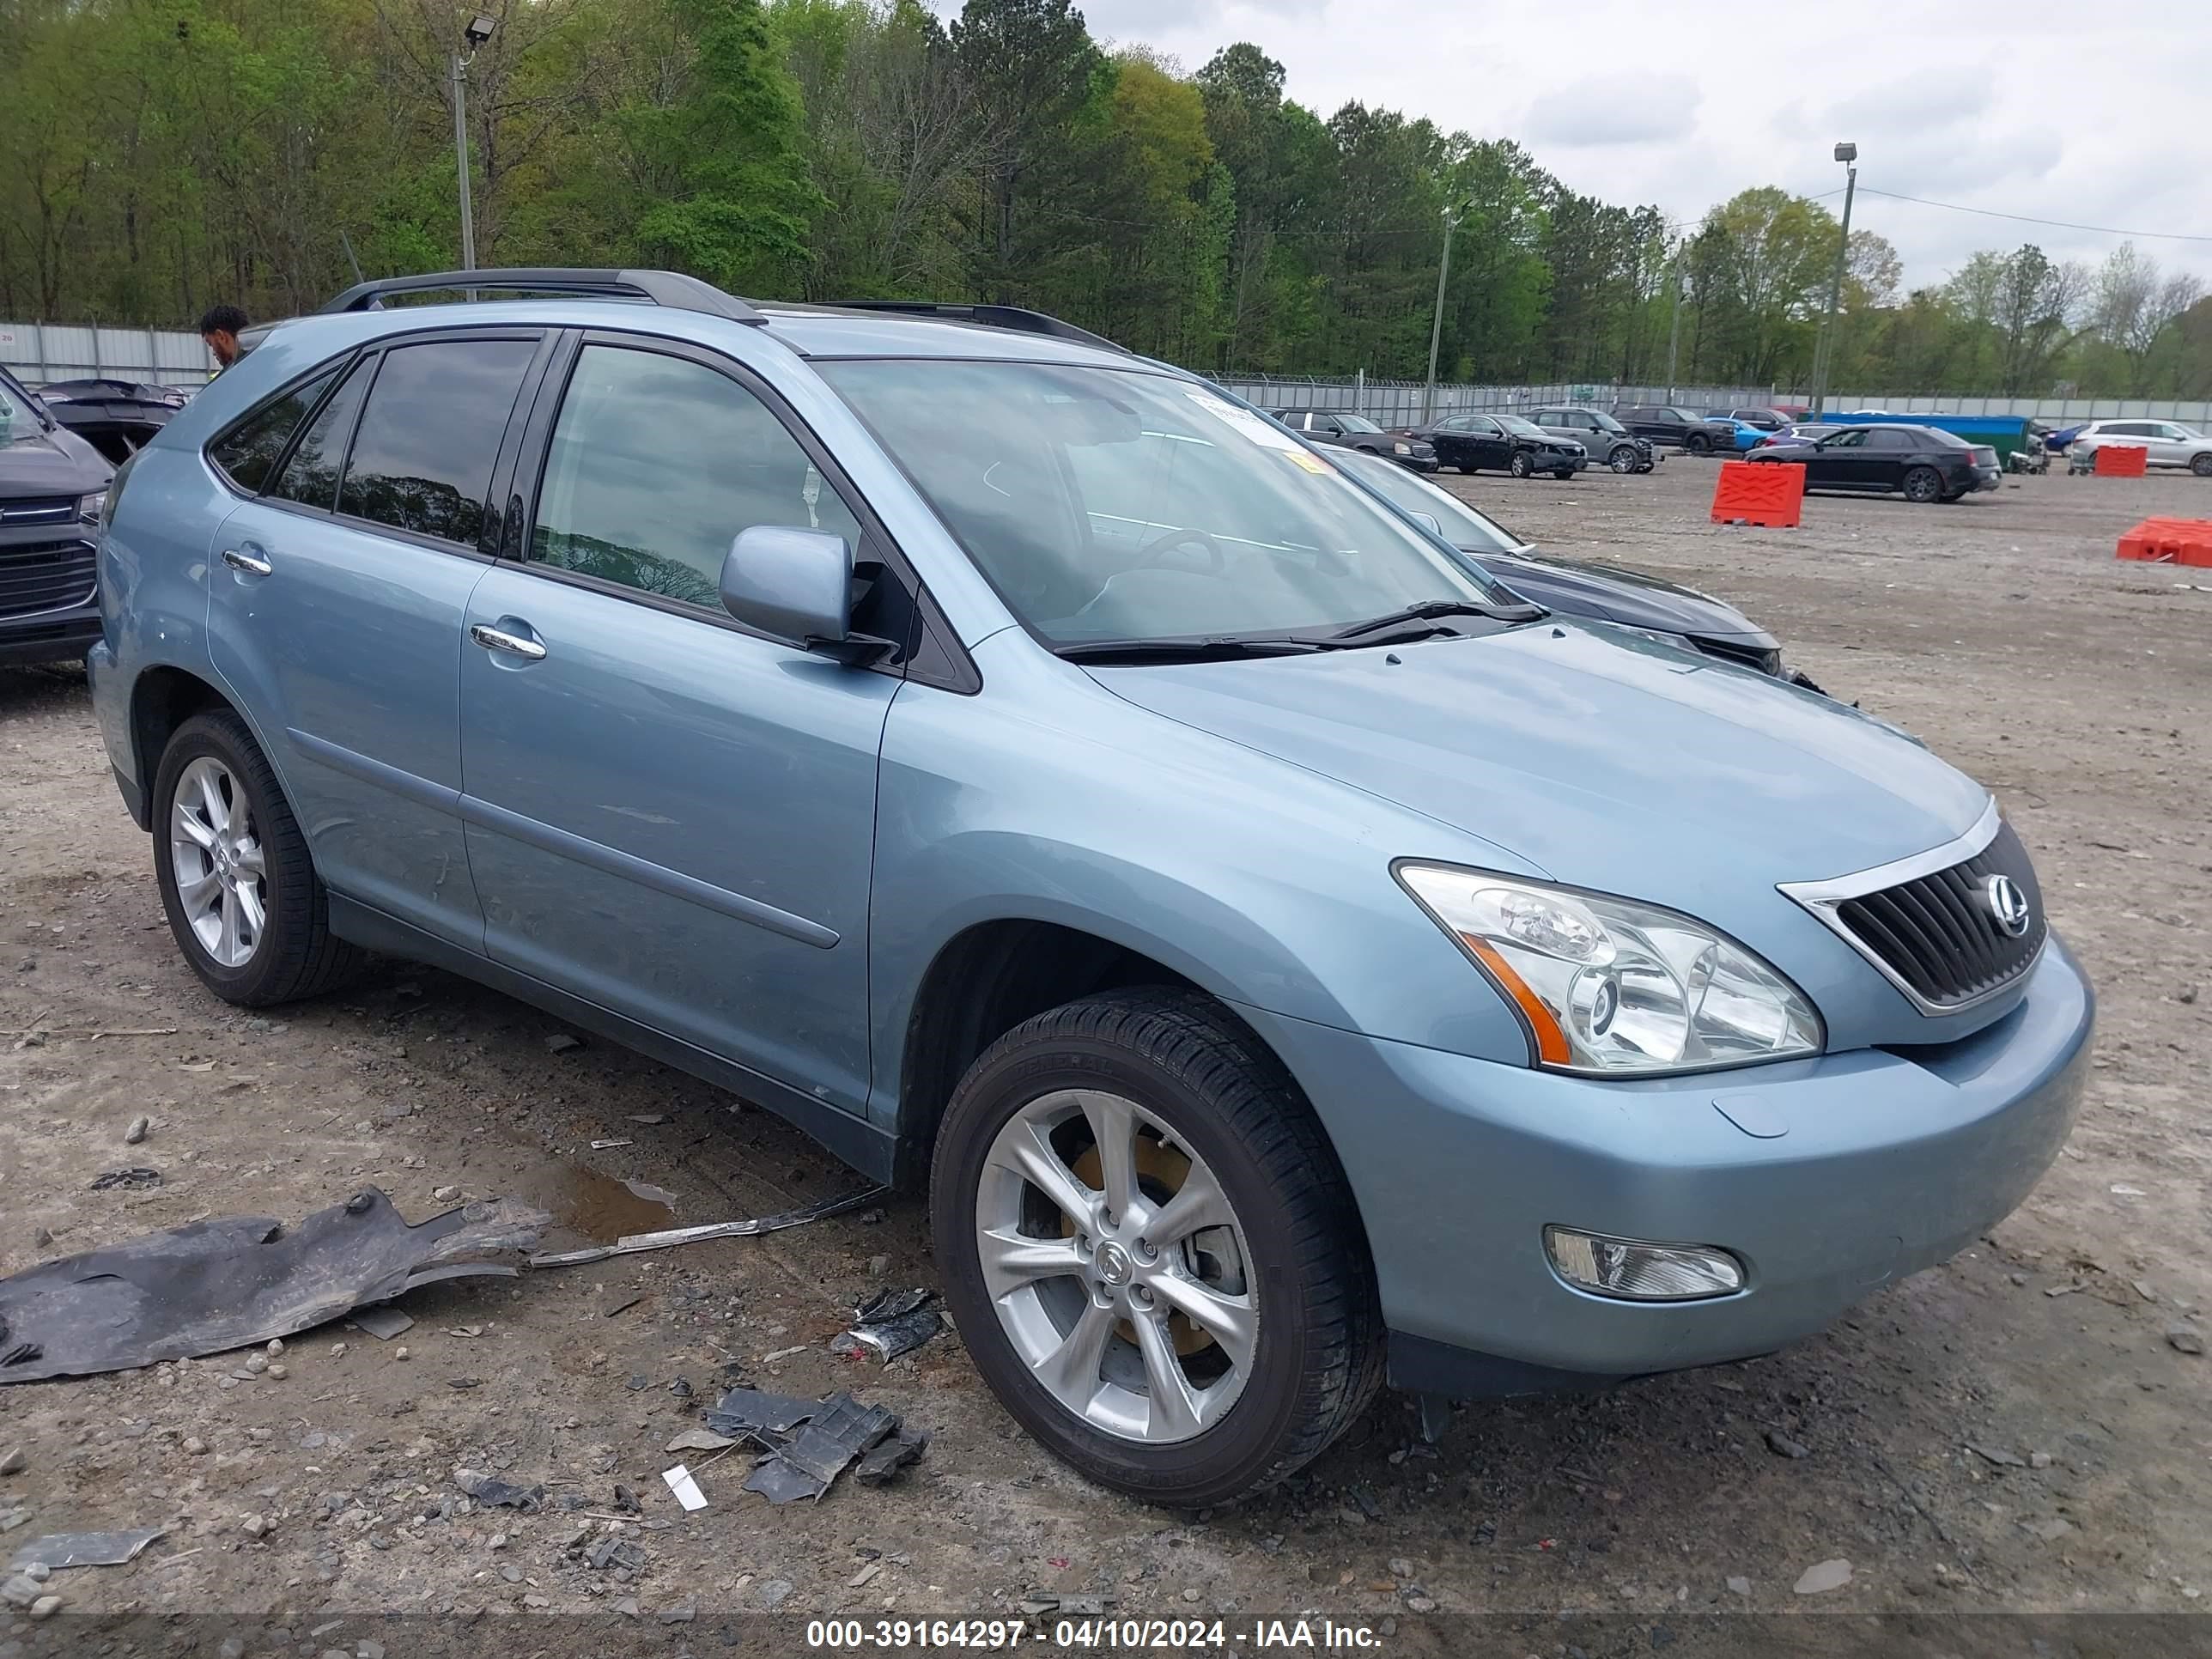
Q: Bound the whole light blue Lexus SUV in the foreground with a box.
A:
[93,270,2090,1504]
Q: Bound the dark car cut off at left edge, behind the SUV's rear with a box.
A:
[0,369,115,664]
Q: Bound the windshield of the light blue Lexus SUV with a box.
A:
[818,358,1517,644]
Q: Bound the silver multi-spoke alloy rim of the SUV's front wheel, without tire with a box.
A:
[975,1088,1259,1444]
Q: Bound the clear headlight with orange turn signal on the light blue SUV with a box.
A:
[1395,863,1823,1075]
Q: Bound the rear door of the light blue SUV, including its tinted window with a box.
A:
[208,330,546,951]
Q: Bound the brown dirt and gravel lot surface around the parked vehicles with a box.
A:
[0,460,2212,1659]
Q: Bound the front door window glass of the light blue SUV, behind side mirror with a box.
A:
[531,345,860,611]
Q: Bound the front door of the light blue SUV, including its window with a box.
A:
[460,337,900,1113]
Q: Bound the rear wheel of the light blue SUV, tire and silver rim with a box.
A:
[153,710,358,1009]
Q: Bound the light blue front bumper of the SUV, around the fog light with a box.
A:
[1248,933,2094,1394]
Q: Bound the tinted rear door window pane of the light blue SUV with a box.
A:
[338,341,538,546]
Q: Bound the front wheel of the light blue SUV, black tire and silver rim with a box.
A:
[931,987,1382,1509]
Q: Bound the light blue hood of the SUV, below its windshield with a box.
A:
[1091,619,1989,911]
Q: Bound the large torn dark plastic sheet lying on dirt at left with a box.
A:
[0,1188,553,1382]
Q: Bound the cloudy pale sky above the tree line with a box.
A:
[938,0,2212,285]
